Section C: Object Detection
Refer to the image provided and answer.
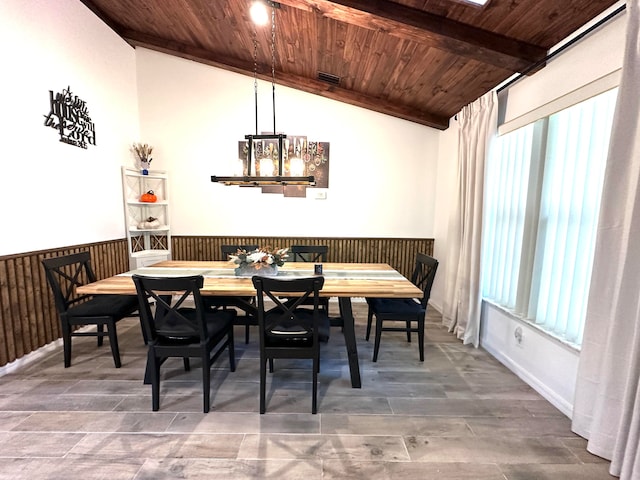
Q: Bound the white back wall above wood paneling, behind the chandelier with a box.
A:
[131,48,439,238]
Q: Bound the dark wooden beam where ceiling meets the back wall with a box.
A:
[118,30,449,130]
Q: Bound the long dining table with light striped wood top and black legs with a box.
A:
[77,260,422,388]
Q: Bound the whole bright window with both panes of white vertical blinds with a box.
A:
[482,89,617,345]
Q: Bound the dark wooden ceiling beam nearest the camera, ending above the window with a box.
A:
[279,0,547,73]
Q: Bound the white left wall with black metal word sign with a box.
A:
[0,0,138,255]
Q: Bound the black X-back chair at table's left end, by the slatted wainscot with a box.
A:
[42,252,138,368]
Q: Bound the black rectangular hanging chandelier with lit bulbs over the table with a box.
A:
[211,0,315,187]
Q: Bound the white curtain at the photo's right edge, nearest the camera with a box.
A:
[572,0,640,480]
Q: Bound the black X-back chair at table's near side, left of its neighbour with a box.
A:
[133,275,236,413]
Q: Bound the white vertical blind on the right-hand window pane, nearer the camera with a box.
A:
[529,91,615,344]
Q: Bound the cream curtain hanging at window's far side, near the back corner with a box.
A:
[443,92,498,347]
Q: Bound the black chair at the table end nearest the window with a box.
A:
[365,253,438,362]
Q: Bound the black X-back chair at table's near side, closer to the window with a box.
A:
[252,275,329,413]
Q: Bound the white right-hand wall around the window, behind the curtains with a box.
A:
[432,2,626,417]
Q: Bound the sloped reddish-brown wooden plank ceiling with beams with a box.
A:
[81,0,616,130]
